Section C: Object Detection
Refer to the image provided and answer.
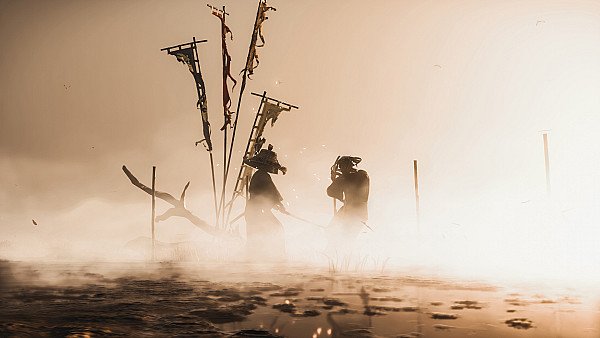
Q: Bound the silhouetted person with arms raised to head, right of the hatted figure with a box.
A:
[327,156,369,249]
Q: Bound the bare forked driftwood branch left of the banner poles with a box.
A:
[122,166,225,236]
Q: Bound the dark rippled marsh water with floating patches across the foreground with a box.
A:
[0,261,600,338]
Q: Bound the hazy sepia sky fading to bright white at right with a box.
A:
[0,0,600,278]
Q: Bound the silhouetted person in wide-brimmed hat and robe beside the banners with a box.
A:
[244,144,286,260]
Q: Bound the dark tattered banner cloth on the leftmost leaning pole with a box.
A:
[168,46,212,151]
